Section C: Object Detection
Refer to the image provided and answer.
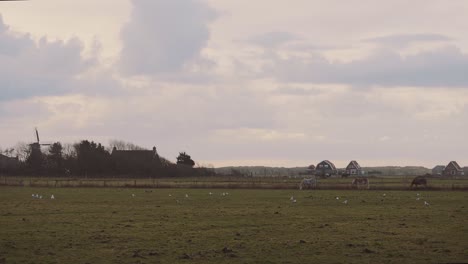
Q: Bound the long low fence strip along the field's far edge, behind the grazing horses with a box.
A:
[0,176,468,190]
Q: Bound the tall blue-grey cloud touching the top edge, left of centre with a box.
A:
[119,0,215,75]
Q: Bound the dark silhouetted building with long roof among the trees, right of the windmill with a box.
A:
[111,147,161,173]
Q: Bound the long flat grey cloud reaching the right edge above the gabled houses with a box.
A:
[266,47,468,87]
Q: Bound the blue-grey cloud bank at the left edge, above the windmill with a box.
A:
[0,16,95,101]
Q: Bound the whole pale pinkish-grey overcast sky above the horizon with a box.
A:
[0,0,468,167]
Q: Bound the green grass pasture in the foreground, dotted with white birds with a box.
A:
[0,187,468,263]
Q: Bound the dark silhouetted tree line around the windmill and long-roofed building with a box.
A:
[0,140,215,178]
